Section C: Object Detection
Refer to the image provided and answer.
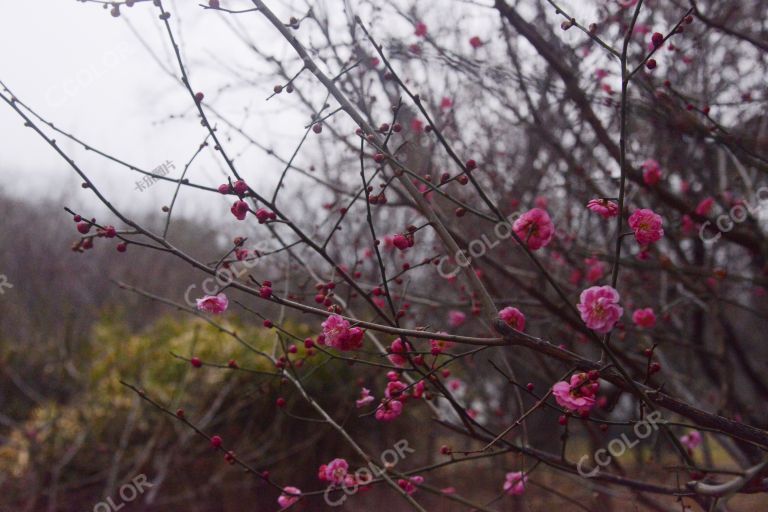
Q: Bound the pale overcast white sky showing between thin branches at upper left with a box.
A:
[0,0,326,218]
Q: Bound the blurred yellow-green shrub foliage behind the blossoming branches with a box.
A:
[0,312,308,476]
